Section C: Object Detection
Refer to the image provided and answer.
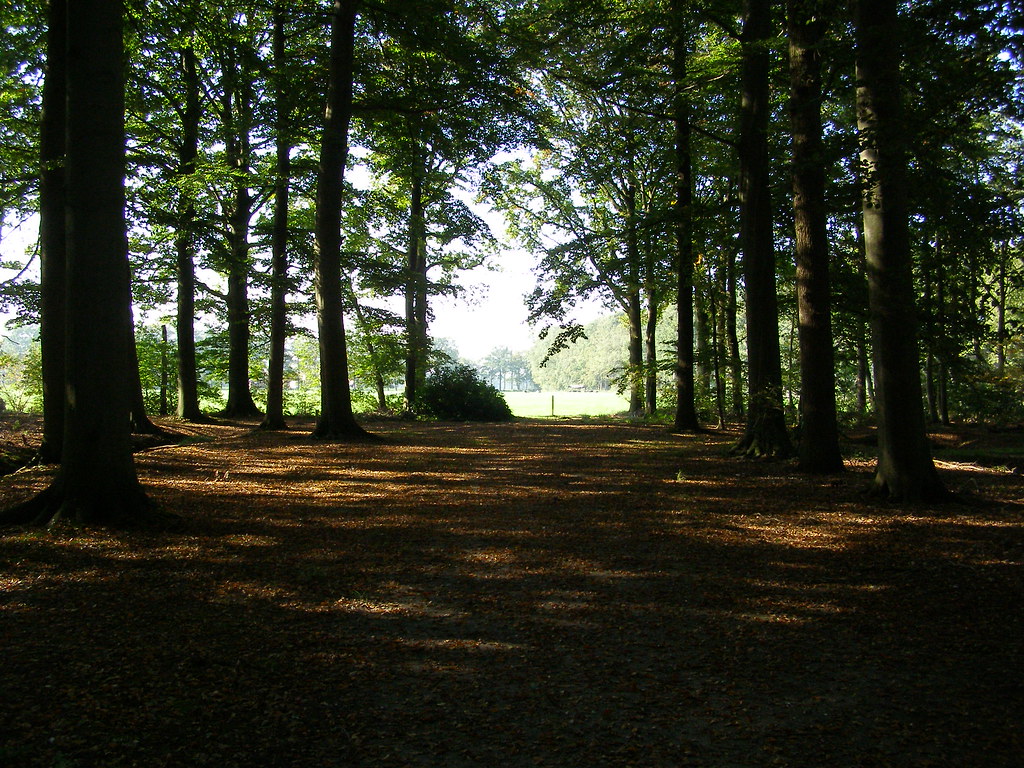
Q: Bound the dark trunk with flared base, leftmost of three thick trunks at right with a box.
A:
[733,0,793,458]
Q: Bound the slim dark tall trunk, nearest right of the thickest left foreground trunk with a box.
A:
[174,43,203,421]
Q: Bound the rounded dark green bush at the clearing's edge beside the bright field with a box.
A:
[416,364,512,421]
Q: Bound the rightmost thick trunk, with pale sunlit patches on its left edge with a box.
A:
[856,0,945,502]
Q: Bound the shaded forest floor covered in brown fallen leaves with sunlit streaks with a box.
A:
[0,416,1024,768]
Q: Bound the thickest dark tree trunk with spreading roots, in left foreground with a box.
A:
[0,0,147,524]
